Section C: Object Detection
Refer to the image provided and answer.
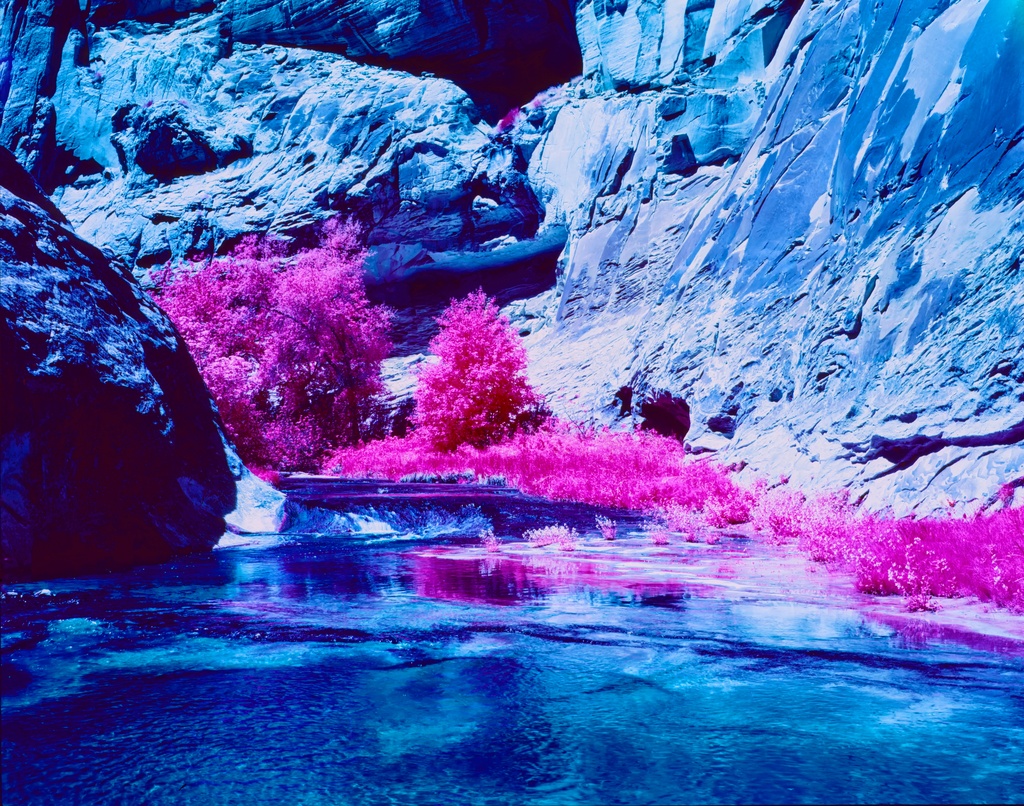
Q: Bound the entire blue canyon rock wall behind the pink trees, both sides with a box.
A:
[0,0,1024,510]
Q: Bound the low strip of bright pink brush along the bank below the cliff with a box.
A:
[329,422,1024,611]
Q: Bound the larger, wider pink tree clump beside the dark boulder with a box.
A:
[157,222,391,469]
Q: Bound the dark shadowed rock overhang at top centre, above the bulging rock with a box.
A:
[226,0,581,122]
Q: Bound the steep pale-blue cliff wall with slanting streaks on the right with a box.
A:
[520,0,1024,511]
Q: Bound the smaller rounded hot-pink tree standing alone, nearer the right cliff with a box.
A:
[414,291,543,451]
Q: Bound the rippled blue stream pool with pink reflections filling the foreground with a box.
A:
[2,495,1024,806]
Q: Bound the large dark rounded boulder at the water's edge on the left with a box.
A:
[0,149,236,580]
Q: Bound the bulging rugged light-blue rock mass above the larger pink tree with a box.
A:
[32,8,564,282]
